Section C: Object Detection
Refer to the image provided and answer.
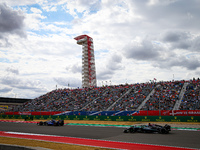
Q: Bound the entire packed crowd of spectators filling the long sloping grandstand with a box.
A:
[6,80,200,112]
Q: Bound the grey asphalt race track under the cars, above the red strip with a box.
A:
[0,122,200,149]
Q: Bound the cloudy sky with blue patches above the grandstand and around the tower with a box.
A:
[0,0,200,98]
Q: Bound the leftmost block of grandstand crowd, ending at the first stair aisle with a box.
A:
[12,87,108,111]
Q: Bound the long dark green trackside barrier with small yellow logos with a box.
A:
[0,115,200,122]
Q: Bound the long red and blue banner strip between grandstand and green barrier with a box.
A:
[4,110,200,116]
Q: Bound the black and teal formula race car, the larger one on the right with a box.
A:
[124,123,171,134]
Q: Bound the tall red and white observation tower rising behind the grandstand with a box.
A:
[74,35,97,88]
